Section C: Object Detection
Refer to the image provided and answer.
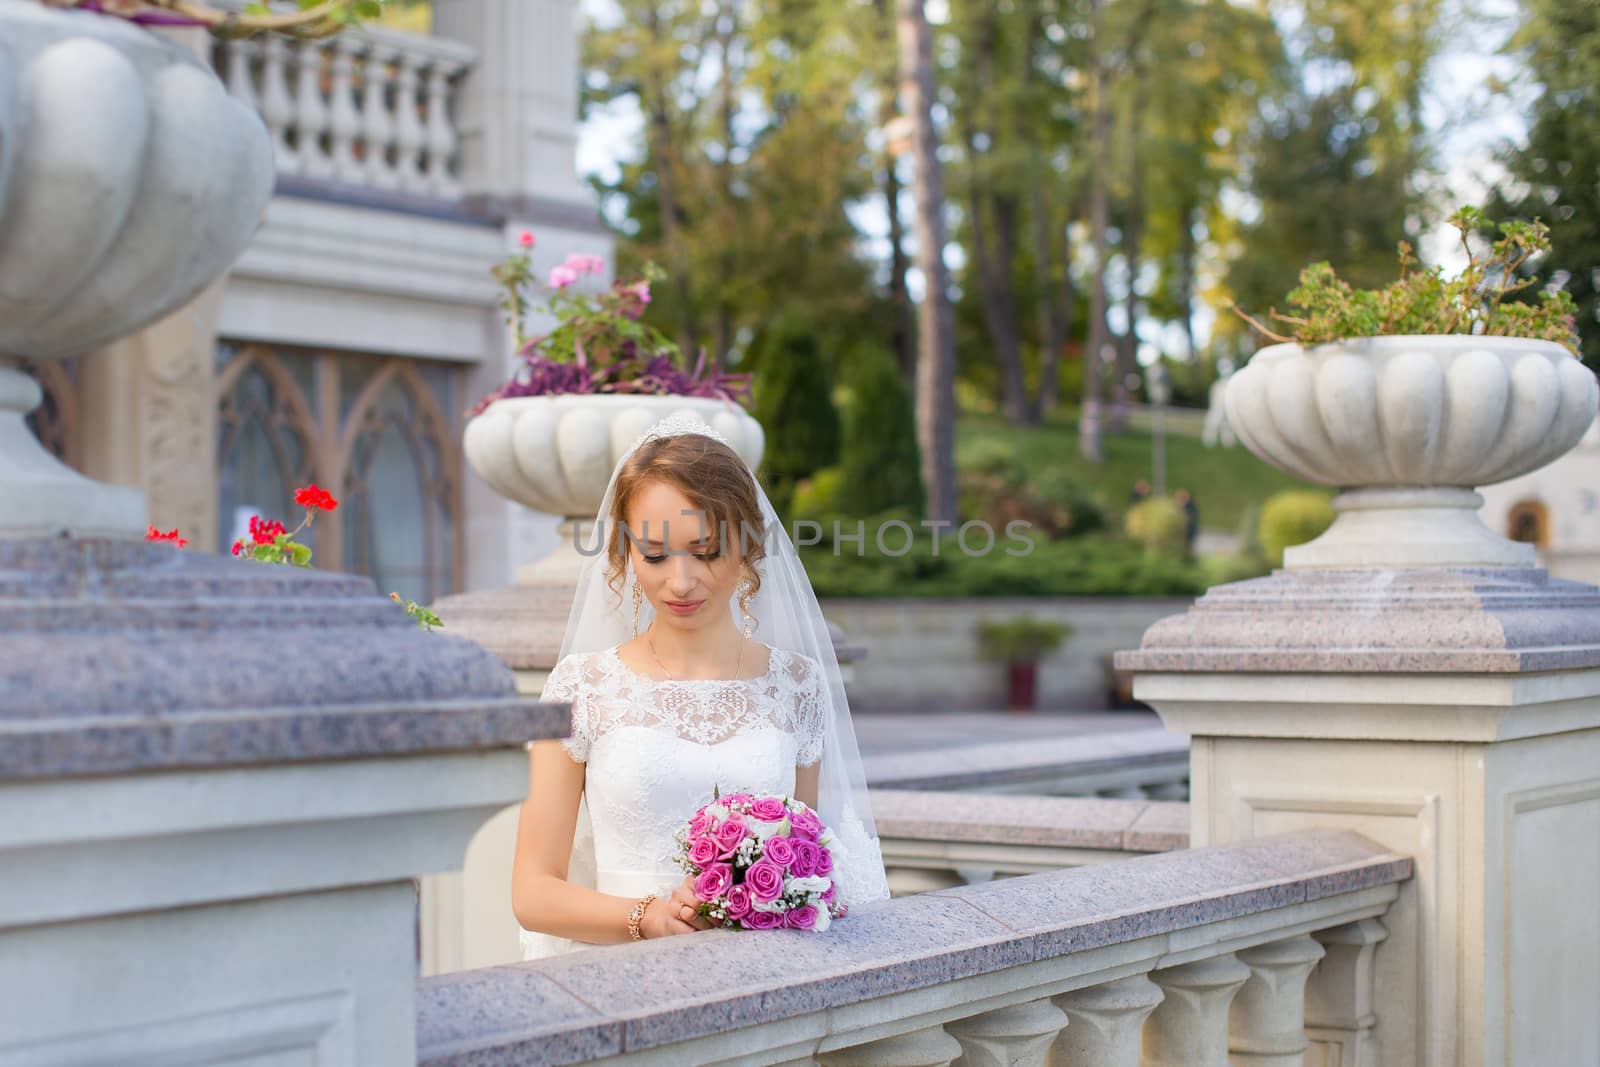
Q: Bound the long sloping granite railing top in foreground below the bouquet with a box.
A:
[418,830,1411,1067]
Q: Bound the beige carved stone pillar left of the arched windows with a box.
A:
[78,282,226,552]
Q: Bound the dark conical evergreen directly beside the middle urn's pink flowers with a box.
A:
[755,318,838,515]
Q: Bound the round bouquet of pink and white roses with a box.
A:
[675,790,848,933]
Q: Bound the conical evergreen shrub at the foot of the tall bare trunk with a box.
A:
[840,354,923,515]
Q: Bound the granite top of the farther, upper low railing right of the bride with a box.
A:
[862,726,1189,790]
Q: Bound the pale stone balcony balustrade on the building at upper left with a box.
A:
[213,26,475,200]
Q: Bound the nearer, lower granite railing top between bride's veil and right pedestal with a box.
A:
[872,789,1189,853]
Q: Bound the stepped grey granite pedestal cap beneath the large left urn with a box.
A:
[0,537,568,782]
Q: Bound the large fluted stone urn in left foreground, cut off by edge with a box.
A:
[0,0,274,536]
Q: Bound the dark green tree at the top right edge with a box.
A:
[1490,0,1600,370]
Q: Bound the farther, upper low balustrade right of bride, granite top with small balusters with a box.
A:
[862,728,1189,800]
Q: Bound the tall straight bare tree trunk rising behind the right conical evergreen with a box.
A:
[896,0,957,523]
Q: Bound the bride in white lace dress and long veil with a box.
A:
[512,416,888,958]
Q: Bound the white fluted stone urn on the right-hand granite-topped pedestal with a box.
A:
[1226,334,1600,569]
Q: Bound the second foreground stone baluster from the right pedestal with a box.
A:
[1229,936,1322,1067]
